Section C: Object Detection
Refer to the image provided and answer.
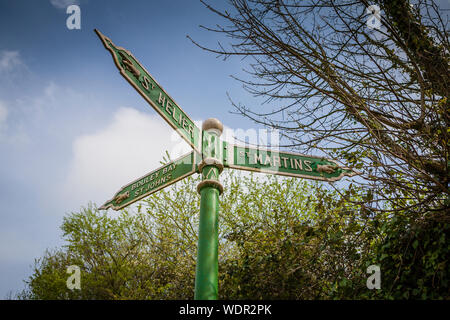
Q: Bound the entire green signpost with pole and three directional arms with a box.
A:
[95,30,358,300]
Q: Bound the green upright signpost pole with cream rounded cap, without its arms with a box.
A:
[194,119,223,300]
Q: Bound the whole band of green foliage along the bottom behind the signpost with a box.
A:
[19,170,450,299]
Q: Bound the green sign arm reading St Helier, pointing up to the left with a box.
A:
[95,29,201,152]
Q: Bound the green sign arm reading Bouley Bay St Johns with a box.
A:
[99,151,198,210]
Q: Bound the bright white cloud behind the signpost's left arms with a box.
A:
[62,108,191,209]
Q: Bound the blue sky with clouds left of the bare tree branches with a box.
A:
[0,0,268,298]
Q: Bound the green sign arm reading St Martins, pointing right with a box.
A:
[223,142,359,181]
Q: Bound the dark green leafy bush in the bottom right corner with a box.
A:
[373,217,450,299]
